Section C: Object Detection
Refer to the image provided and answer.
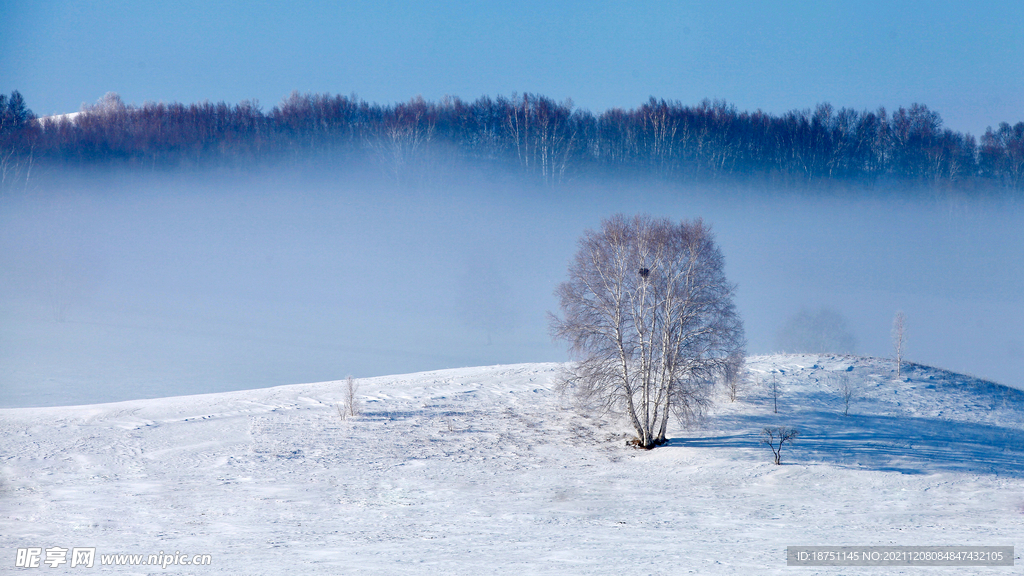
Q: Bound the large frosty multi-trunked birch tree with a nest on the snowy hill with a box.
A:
[551,214,743,449]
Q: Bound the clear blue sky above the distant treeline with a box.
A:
[0,0,1024,135]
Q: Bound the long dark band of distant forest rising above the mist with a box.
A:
[0,92,1024,189]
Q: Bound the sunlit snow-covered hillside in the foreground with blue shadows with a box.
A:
[0,356,1024,576]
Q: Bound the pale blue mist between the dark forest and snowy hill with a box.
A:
[0,169,1024,407]
